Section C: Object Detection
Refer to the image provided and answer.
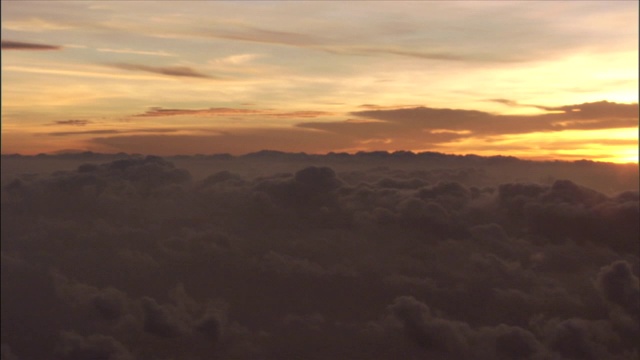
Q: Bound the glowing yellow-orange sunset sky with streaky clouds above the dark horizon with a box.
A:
[2,1,638,163]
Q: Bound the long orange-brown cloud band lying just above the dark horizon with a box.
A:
[74,101,638,161]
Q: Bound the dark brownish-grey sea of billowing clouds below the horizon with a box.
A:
[0,155,640,360]
